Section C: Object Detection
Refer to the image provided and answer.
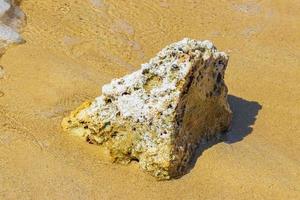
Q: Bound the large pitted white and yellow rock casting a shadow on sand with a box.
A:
[62,38,232,179]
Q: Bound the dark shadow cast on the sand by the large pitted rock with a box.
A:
[183,95,262,179]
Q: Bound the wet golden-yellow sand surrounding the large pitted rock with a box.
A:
[0,0,300,199]
